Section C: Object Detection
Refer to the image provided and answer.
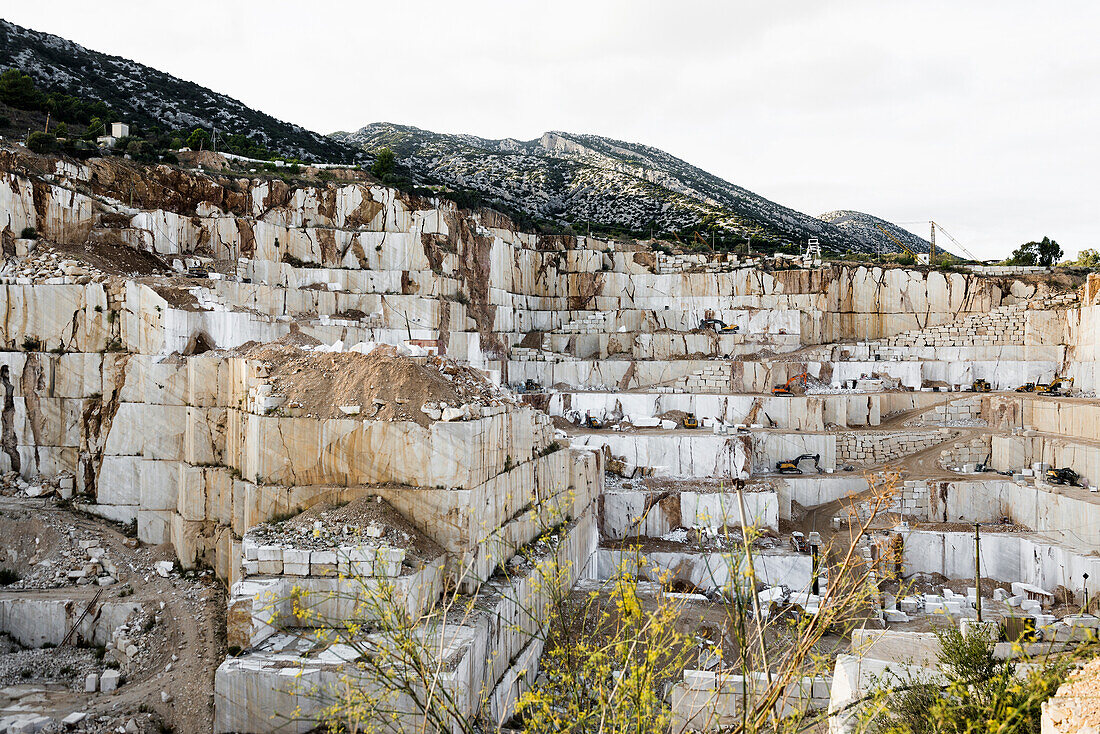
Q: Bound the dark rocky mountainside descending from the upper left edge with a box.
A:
[0,19,362,163]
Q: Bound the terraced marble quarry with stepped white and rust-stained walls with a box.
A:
[0,141,1100,734]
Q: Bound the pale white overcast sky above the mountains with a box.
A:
[3,0,1100,258]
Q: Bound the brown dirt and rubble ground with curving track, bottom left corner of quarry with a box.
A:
[0,497,226,734]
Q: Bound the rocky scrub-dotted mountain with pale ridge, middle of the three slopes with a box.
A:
[333,122,880,250]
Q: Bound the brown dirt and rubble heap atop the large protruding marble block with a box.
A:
[239,343,505,426]
